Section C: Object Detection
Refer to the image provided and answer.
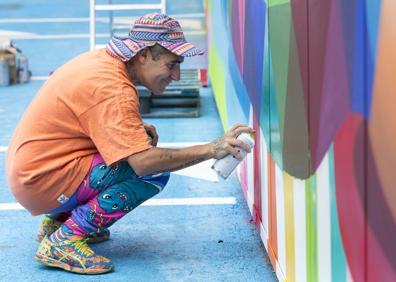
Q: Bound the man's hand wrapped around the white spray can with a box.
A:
[210,124,255,160]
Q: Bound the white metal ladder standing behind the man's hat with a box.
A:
[89,0,166,51]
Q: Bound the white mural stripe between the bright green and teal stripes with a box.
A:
[316,154,332,282]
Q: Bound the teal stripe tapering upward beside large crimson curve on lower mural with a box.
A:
[328,146,347,282]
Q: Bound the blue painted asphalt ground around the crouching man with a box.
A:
[0,0,276,281]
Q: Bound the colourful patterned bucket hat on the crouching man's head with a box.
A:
[106,14,204,62]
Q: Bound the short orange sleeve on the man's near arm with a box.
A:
[79,87,152,165]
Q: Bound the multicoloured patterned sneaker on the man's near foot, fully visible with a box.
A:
[34,236,114,274]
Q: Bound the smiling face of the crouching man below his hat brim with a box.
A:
[138,50,184,94]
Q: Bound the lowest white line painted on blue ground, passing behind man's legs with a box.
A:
[0,197,236,211]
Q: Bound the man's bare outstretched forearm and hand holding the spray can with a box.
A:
[128,125,253,176]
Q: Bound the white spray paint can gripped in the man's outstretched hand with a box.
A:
[212,133,254,179]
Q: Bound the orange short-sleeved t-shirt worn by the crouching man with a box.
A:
[6,49,151,215]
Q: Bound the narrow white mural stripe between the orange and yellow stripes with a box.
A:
[275,165,286,277]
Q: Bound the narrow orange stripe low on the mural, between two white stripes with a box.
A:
[267,152,278,268]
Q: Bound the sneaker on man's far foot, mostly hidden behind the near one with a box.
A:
[36,216,110,244]
